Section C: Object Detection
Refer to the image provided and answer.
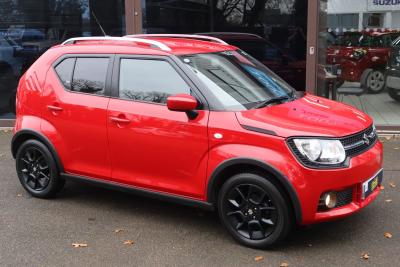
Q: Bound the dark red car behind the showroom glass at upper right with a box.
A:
[326,31,400,94]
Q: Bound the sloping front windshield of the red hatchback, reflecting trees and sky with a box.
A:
[180,50,294,110]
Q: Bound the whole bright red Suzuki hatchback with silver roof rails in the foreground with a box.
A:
[12,35,382,248]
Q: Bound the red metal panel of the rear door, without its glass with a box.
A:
[41,68,111,178]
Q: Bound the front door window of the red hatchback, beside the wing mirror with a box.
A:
[119,59,191,103]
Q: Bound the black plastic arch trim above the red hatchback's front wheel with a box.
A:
[207,158,302,224]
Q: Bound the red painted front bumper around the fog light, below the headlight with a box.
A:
[292,140,383,224]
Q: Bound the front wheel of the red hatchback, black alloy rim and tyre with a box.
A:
[218,173,293,248]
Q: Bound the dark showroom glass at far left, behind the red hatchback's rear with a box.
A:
[0,0,125,119]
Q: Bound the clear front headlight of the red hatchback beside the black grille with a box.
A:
[293,138,346,165]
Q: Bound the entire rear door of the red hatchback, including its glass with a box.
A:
[42,55,114,178]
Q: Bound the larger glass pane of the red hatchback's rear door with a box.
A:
[71,58,109,95]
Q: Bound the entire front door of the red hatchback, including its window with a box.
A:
[107,56,208,198]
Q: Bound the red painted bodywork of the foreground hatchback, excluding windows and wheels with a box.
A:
[14,39,382,224]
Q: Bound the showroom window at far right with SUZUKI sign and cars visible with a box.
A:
[317,0,400,129]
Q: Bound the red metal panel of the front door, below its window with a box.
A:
[107,99,209,199]
